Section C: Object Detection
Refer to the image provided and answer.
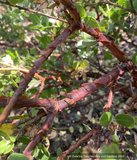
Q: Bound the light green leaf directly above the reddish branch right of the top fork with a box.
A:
[85,16,99,28]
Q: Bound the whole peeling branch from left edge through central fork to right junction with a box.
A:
[0,68,124,110]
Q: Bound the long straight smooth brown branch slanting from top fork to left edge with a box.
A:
[0,26,77,127]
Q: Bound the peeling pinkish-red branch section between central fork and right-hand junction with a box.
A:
[59,68,123,111]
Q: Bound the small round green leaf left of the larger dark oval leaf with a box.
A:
[99,112,112,127]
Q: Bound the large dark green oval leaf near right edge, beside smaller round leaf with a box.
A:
[115,114,135,128]
